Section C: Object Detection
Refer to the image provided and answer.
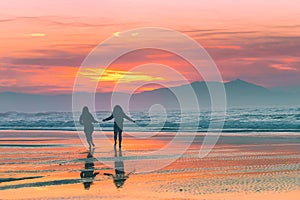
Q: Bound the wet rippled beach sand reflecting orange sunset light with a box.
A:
[0,131,300,200]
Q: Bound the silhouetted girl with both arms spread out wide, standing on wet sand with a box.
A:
[102,105,135,148]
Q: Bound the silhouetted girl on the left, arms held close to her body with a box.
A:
[79,106,98,148]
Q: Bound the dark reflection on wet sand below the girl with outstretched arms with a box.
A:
[104,148,133,188]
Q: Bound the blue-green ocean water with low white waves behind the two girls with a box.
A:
[0,107,300,133]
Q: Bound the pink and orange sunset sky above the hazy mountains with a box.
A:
[0,0,300,94]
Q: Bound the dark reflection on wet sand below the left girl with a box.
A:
[80,152,99,190]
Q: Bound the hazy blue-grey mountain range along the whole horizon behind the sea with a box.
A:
[0,79,300,112]
